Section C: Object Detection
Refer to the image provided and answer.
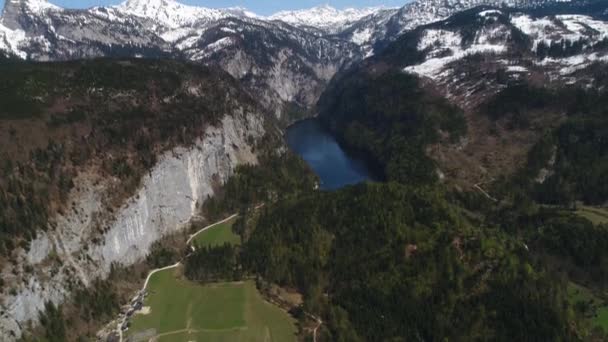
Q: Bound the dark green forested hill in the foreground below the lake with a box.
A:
[244,183,580,341]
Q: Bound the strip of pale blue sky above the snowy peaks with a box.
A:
[0,0,408,15]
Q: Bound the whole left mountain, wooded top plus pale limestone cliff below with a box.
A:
[0,60,268,340]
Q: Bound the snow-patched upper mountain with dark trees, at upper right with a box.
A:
[388,3,608,108]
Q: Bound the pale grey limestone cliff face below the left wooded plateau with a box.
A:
[0,113,264,341]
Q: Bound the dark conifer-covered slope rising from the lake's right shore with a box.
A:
[319,71,467,184]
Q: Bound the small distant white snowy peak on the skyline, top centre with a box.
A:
[268,5,386,29]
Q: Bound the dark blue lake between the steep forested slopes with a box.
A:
[287,119,373,190]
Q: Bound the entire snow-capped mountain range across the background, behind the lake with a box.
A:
[0,0,600,116]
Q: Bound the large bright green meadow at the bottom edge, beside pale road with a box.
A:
[128,268,296,342]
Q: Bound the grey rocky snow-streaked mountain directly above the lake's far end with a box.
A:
[177,18,361,116]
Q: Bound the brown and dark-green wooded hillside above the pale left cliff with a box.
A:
[0,60,266,255]
